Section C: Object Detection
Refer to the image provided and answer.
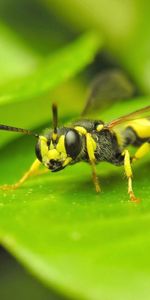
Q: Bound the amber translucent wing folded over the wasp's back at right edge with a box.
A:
[106,105,150,129]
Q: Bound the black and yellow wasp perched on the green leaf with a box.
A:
[0,70,150,202]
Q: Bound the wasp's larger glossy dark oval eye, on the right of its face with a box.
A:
[65,129,82,159]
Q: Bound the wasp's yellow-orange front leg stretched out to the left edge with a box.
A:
[0,159,48,191]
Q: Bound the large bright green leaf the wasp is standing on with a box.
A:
[0,98,150,300]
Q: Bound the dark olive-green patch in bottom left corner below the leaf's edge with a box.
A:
[0,247,63,300]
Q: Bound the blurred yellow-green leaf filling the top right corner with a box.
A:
[48,0,150,94]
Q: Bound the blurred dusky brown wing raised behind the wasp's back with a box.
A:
[81,69,137,116]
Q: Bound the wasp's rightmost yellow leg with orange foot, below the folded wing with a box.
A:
[122,150,140,202]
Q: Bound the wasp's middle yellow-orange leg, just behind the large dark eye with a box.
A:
[86,133,101,193]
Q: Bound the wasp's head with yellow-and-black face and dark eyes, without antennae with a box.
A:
[36,128,82,172]
